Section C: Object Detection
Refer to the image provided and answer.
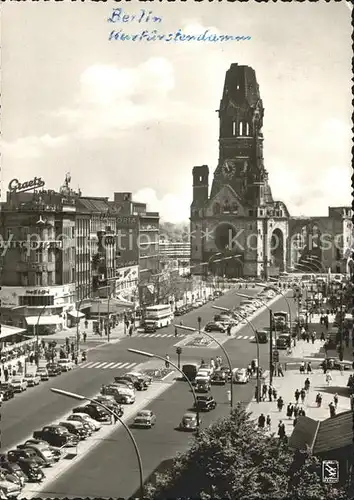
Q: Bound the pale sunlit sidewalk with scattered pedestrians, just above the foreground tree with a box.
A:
[247,369,352,437]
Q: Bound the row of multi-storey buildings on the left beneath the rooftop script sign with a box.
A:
[0,175,159,334]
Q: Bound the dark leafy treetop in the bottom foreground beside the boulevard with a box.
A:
[146,404,347,500]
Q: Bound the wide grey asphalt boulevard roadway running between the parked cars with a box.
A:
[7,288,295,498]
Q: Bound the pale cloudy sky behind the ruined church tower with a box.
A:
[1,0,352,222]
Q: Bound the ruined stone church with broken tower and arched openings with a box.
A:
[190,64,352,278]
